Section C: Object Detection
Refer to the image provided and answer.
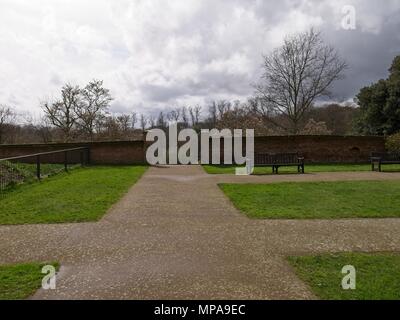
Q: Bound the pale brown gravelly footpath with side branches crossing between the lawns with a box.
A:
[0,166,400,299]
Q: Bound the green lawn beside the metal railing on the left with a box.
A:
[0,166,146,225]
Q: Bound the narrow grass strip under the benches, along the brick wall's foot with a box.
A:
[203,164,400,175]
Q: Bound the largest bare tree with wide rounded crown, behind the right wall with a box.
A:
[255,29,347,134]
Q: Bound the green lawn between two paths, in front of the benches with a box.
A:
[220,181,400,219]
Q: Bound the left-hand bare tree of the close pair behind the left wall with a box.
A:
[42,84,81,141]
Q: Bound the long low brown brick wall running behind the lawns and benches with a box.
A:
[0,136,385,164]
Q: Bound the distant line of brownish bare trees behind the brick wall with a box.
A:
[0,100,359,144]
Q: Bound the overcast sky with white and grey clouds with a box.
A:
[0,0,400,119]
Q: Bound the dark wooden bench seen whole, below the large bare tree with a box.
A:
[254,153,304,174]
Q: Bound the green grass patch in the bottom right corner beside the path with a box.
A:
[289,253,400,300]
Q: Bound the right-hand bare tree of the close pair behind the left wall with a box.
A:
[75,80,112,140]
